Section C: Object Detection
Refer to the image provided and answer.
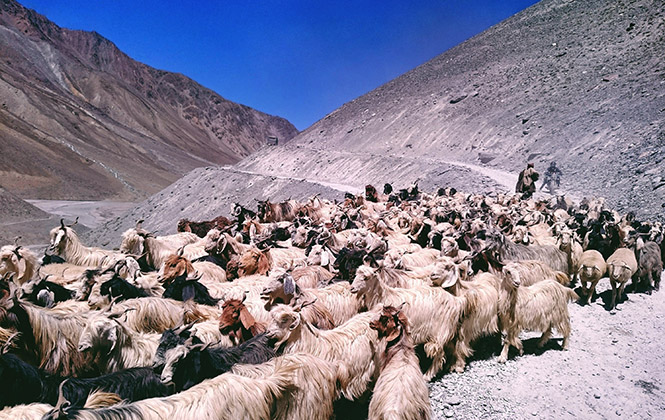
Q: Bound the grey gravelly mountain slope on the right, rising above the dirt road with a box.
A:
[239,0,665,217]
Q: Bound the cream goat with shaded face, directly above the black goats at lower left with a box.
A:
[78,313,160,372]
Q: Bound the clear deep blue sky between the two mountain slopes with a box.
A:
[19,0,536,130]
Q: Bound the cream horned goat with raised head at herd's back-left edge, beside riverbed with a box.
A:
[50,219,125,267]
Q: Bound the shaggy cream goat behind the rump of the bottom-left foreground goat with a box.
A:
[231,353,339,420]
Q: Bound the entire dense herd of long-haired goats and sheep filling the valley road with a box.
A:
[0,184,665,420]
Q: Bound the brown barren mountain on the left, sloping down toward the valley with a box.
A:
[0,0,297,199]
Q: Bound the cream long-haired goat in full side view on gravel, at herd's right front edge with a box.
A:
[498,267,579,363]
